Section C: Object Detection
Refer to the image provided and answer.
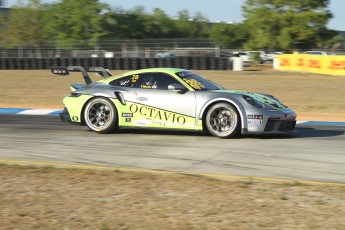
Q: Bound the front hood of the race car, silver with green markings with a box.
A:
[208,90,287,109]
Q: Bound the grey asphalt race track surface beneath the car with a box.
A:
[0,114,345,183]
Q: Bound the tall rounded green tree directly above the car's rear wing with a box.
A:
[43,0,109,48]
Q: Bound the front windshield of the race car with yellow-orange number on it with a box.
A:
[176,71,224,91]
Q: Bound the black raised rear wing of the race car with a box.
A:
[50,66,111,85]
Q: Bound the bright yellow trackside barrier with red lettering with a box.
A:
[274,54,345,76]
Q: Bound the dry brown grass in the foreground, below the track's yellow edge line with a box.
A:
[0,165,345,230]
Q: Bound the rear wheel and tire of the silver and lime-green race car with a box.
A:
[84,98,117,133]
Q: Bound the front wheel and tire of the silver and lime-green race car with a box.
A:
[205,103,241,138]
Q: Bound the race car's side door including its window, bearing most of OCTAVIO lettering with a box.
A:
[131,72,196,128]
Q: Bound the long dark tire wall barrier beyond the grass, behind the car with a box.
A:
[0,57,232,70]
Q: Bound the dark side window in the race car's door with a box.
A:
[139,73,178,90]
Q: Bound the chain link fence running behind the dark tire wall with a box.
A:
[0,38,220,58]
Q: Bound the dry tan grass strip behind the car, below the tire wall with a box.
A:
[0,66,345,121]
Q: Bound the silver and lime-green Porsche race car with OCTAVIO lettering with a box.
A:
[51,66,297,138]
